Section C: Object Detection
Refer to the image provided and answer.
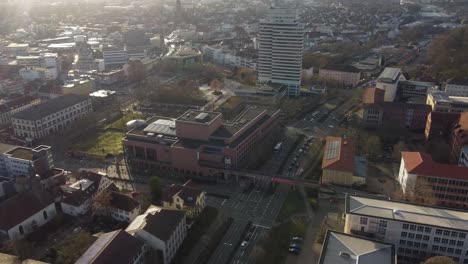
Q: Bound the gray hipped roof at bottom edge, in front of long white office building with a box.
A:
[318,230,396,264]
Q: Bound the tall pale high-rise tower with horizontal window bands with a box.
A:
[257,4,304,96]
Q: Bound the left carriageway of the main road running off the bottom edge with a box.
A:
[208,219,248,264]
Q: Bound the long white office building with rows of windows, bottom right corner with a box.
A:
[344,195,468,264]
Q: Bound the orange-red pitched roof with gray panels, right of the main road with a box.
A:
[322,137,355,173]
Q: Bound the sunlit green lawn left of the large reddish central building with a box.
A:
[73,131,125,157]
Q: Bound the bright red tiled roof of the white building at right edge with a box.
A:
[401,152,468,180]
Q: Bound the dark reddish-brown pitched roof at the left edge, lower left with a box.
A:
[0,191,54,230]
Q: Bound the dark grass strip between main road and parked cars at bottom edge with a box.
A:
[254,220,307,264]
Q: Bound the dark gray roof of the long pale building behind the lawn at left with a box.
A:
[12,94,89,121]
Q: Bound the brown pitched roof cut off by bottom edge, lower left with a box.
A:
[75,230,143,264]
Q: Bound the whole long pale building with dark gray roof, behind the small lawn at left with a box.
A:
[11,94,92,139]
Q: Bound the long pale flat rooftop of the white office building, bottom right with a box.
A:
[345,195,468,232]
